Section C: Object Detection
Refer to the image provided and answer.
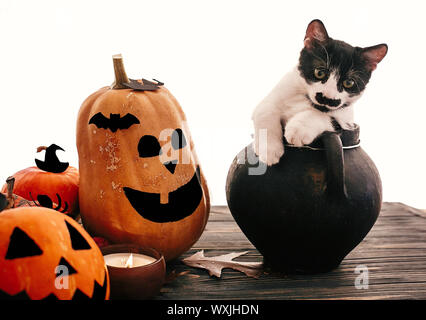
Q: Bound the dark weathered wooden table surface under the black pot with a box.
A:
[155,202,426,300]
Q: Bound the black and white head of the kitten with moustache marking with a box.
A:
[298,20,388,112]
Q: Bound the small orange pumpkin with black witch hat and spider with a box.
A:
[2,144,79,216]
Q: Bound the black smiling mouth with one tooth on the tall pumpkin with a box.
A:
[123,167,203,223]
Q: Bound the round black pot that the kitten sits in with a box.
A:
[226,126,382,273]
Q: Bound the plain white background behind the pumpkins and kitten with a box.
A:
[0,0,426,208]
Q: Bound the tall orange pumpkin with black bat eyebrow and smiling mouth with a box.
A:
[77,55,210,260]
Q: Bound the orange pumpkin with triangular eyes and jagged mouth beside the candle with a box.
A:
[0,207,109,300]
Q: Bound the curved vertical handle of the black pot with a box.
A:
[321,132,347,200]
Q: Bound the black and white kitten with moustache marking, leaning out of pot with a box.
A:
[252,20,388,165]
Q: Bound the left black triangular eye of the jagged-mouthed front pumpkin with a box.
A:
[5,227,43,260]
